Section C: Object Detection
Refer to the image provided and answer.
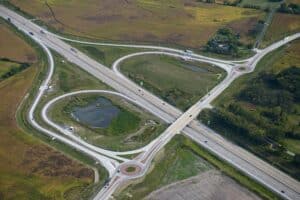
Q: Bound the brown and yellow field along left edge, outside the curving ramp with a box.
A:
[0,25,93,199]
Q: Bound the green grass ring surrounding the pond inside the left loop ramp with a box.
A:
[50,94,165,151]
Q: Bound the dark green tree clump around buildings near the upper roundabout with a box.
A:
[205,28,252,57]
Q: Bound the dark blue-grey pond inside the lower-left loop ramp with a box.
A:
[71,97,120,128]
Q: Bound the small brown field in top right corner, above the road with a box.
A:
[262,13,300,46]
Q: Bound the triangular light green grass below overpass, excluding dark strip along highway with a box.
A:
[116,135,212,200]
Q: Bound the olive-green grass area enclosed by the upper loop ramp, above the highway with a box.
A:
[120,55,225,110]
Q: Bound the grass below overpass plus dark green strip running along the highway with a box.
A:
[116,135,279,200]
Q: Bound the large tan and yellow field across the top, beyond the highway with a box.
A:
[10,0,264,48]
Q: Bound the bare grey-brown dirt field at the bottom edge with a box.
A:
[145,170,260,200]
